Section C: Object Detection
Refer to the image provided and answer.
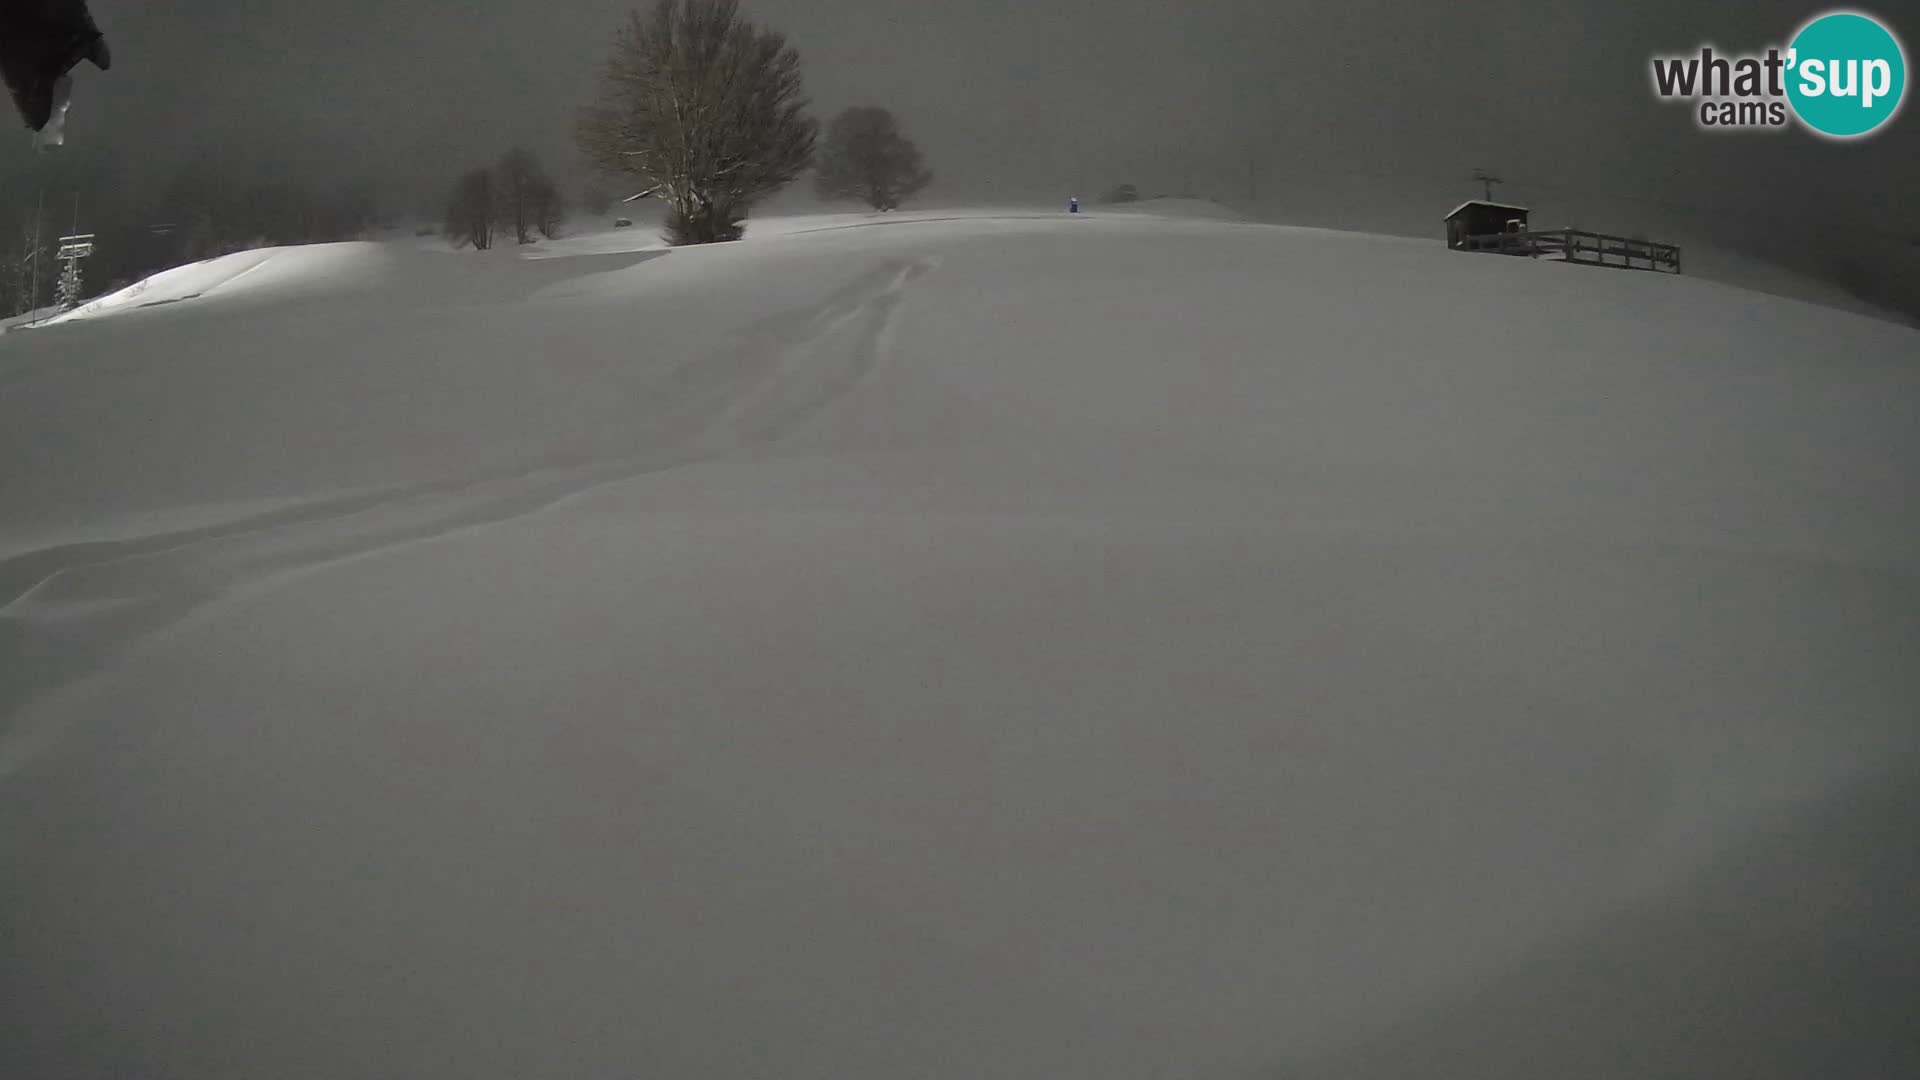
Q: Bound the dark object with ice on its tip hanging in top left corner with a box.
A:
[0,0,113,146]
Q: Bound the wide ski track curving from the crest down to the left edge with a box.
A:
[0,258,939,778]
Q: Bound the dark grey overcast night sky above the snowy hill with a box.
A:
[0,0,1920,234]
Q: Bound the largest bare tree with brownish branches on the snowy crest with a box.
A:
[576,0,816,244]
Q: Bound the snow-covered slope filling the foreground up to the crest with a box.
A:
[0,208,1920,1080]
